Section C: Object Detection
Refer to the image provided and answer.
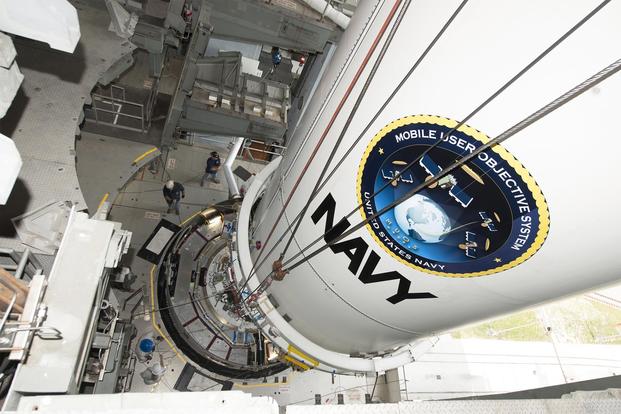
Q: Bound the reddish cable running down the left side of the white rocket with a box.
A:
[244,0,402,287]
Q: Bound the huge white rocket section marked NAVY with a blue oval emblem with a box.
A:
[233,0,621,372]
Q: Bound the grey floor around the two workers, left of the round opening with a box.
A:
[76,132,263,233]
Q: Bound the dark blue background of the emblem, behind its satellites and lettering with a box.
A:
[360,123,540,274]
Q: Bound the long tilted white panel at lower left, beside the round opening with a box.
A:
[13,211,114,393]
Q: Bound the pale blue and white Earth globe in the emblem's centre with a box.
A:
[394,194,451,243]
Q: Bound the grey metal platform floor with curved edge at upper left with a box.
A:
[0,0,134,249]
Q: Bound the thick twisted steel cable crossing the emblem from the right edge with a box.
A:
[283,59,621,272]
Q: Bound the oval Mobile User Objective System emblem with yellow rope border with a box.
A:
[357,115,550,277]
